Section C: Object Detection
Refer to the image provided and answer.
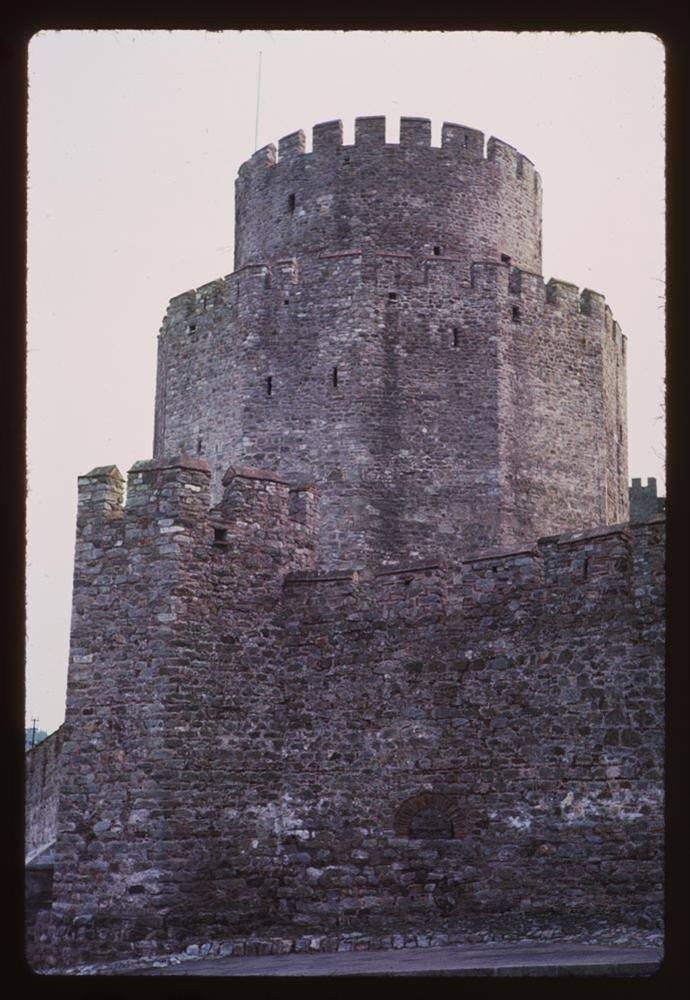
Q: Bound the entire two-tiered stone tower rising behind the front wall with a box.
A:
[154,118,628,568]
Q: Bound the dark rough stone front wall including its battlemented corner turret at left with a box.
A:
[33,457,664,964]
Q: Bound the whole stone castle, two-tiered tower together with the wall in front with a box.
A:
[28,118,664,964]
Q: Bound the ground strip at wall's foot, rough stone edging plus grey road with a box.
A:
[30,928,663,976]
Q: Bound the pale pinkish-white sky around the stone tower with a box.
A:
[26,31,665,732]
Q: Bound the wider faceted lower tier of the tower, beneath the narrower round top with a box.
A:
[154,249,628,567]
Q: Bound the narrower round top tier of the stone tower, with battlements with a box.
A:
[235,117,541,274]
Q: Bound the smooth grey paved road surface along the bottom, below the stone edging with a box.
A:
[129,944,661,976]
